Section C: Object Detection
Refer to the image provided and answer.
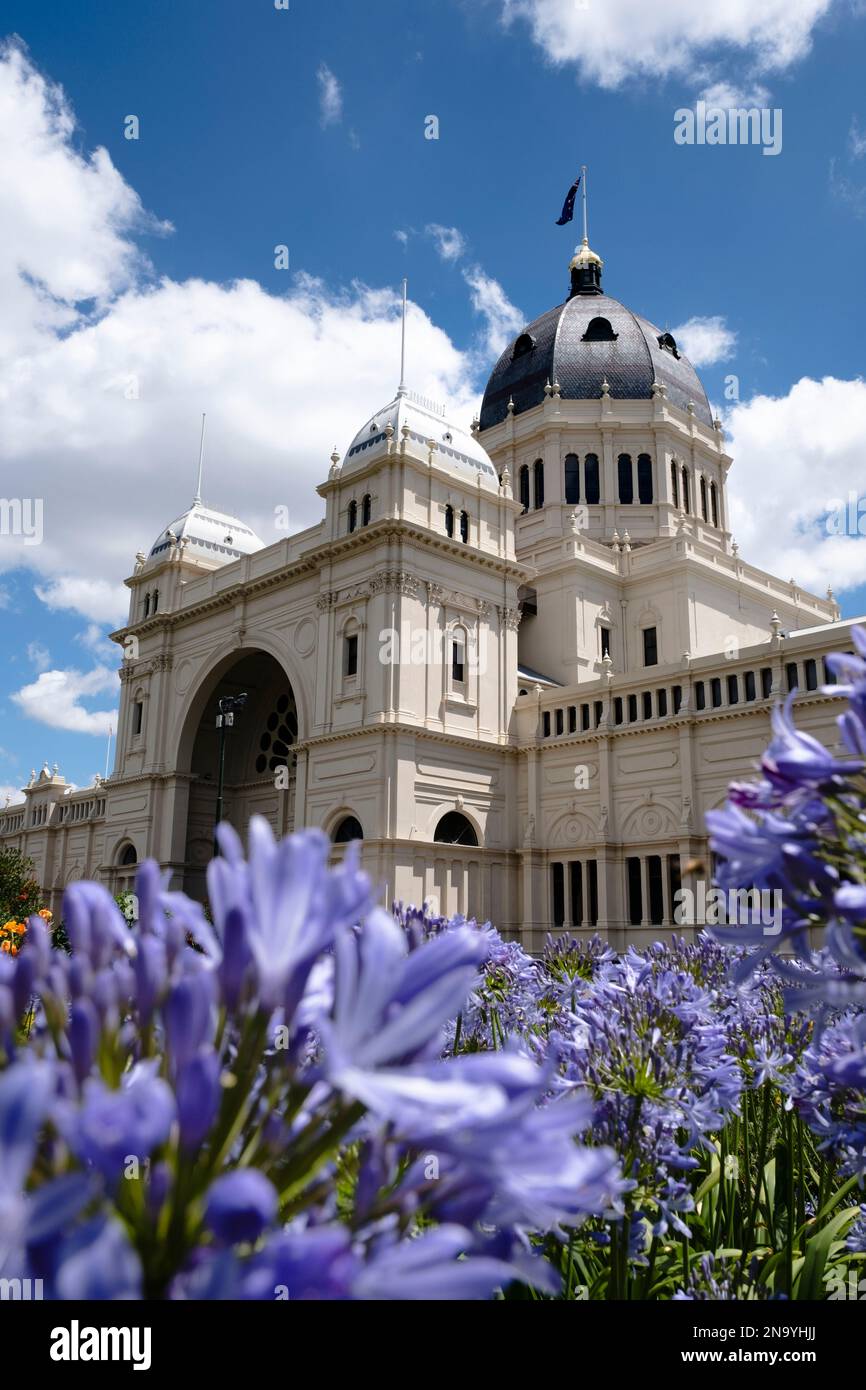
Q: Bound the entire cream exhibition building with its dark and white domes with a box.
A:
[0,243,852,949]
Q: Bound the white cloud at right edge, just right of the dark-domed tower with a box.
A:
[726,377,866,594]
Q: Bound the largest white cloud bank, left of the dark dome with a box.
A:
[0,50,475,626]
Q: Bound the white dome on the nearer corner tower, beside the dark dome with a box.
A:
[342,391,499,489]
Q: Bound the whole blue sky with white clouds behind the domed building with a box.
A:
[0,0,866,806]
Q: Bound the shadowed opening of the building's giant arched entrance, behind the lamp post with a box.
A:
[183,652,297,899]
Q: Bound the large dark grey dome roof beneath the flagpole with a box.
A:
[481,280,713,430]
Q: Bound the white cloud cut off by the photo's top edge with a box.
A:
[502,0,833,88]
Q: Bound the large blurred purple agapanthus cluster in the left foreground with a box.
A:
[0,820,623,1300]
